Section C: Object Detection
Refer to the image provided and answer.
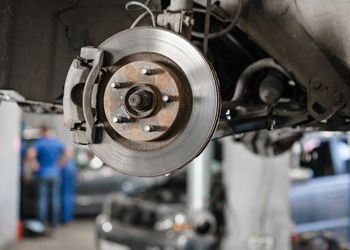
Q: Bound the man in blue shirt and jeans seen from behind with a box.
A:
[27,126,65,227]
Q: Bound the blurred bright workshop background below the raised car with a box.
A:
[0,102,350,250]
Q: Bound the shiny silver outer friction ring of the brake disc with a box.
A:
[89,27,221,176]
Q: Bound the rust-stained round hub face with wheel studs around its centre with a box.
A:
[104,61,183,141]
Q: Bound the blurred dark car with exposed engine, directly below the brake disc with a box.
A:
[96,169,225,250]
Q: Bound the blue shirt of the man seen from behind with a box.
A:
[33,137,64,177]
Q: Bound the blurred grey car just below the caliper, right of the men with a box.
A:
[74,147,164,215]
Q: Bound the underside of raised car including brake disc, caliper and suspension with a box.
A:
[0,0,350,176]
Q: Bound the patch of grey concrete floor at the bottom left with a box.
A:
[8,219,96,250]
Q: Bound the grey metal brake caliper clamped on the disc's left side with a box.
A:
[63,47,103,144]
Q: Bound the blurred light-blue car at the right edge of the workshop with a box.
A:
[290,133,350,244]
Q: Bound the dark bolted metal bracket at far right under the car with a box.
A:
[308,81,345,121]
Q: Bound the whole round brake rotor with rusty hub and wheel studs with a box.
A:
[89,27,220,176]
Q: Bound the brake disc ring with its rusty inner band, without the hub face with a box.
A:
[89,27,221,176]
